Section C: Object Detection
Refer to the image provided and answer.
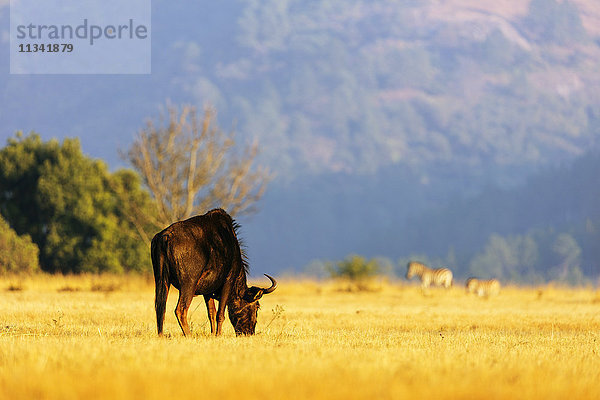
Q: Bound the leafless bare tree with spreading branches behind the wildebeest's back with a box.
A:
[125,104,271,233]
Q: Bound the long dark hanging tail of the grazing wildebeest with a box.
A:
[150,234,170,336]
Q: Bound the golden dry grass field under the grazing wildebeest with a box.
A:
[0,276,600,400]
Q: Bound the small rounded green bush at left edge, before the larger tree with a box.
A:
[0,215,40,274]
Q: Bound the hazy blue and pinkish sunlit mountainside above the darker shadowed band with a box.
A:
[0,0,600,176]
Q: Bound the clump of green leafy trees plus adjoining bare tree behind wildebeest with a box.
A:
[0,104,270,273]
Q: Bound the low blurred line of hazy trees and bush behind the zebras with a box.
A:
[303,230,593,289]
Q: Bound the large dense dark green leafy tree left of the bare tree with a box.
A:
[0,133,149,273]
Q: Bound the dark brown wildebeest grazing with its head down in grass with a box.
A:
[151,209,277,336]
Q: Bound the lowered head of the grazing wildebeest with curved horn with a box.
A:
[228,274,277,336]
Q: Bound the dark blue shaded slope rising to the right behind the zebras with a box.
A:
[306,150,600,284]
